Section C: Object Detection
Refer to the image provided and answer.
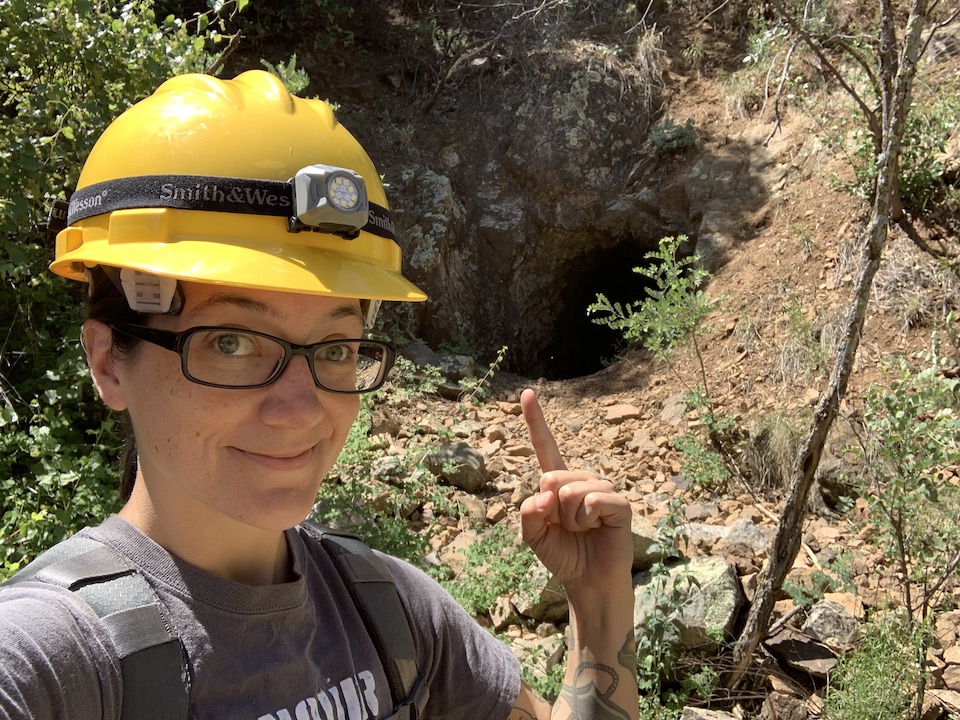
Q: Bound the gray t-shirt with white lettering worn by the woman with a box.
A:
[0,517,520,720]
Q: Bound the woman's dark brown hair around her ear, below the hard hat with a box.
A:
[87,266,146,502]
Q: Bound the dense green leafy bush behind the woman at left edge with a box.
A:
[0,0,231,577]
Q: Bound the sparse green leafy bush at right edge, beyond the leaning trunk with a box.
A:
[824,333,960,720]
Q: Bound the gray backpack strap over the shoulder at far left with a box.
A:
[5,536,190,720]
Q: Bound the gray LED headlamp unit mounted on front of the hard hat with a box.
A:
[289,165,370,237]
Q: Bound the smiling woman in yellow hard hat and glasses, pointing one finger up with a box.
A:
[0,71,637,720]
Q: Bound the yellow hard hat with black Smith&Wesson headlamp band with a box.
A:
[50,70,426,301]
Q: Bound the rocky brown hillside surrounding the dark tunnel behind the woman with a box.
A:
[235,3,960,719]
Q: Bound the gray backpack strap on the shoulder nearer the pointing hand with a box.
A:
[302,520,430,720]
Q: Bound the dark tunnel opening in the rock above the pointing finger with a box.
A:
[537,241,653,380]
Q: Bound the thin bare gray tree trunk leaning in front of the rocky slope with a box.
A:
[727,0,927,687]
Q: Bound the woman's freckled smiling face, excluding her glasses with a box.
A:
[91,283,363,530]
